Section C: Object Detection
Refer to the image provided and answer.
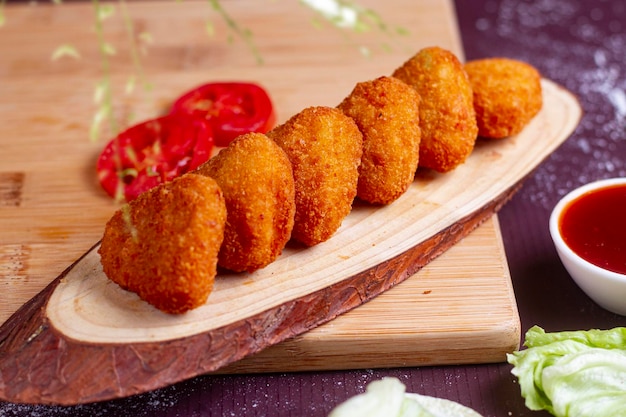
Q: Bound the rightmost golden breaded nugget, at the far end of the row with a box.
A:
[465,58,543,139]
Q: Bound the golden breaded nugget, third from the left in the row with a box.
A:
[267,107,363,246]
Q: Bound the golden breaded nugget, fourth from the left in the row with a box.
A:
[338,76,420,204]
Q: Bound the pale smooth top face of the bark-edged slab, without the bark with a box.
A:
[40,81,577,343]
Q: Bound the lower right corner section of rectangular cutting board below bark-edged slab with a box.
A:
[219,216,520,373]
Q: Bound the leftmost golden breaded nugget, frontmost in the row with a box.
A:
[98,174,226,314]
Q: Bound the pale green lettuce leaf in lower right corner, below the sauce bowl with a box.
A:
[507,326,626,417]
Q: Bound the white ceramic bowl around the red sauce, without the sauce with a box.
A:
[550,178,626,316]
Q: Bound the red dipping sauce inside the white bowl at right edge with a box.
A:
[559,184,626,274]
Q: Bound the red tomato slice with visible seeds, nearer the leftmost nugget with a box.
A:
[96,115,213,201]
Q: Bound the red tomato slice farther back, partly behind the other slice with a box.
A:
[171,82,276,146]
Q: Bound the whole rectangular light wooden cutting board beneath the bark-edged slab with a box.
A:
[0,0,578,401]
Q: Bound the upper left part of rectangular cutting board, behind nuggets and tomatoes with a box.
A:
[0,0,462,323]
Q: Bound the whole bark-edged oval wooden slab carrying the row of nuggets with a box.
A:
[0,76,580,404]
